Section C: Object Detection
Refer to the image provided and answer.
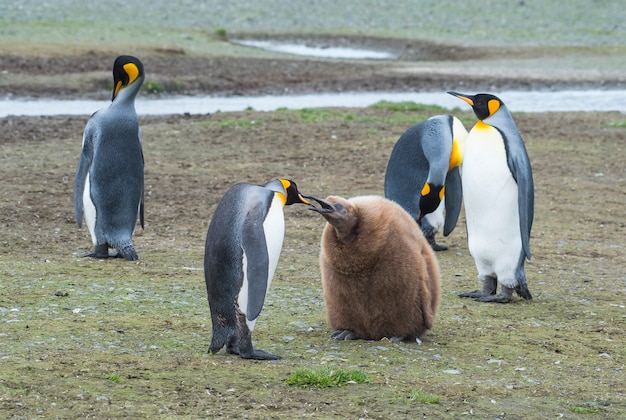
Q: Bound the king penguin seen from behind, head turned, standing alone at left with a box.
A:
[74,55,144,260]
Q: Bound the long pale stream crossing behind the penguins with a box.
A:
[0,90,626,118]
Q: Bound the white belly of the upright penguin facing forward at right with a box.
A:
[461,128,522,284]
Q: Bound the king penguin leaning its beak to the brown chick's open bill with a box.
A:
[204,179,309,360]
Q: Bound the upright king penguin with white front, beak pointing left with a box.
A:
[448,92,534,303]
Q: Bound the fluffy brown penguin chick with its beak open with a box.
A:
[308,196,441,341]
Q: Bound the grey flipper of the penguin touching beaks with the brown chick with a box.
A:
[241,205,269,320]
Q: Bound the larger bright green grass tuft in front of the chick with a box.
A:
[287,366,370,388]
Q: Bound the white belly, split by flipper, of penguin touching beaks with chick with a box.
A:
[237,197,285,332]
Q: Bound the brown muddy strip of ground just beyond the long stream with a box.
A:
[0,34,626,99]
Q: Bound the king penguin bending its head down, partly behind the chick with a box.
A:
[385,115,467,251]
